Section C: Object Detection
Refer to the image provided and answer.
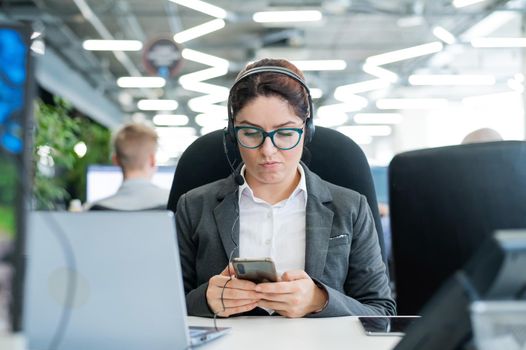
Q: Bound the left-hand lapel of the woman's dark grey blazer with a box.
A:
[214,183,239,259]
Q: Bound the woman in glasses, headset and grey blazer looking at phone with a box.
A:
[177,59,395,317]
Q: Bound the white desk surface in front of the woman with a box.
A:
[188,316,401,350]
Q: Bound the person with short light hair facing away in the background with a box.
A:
[86,123,169,210]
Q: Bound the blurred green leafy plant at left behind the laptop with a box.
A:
[33,98,110,209]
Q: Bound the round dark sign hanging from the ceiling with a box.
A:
[142,39,183,78]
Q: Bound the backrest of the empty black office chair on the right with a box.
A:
[389,141,526,314]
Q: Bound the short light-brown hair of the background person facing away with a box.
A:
[113,123,158,170]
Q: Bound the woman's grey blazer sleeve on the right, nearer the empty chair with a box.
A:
[307,196,396,317]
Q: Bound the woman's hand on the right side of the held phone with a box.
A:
[255,270,328,318]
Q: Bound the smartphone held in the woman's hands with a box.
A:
[232,258,278,283]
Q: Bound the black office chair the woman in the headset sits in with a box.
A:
[168,126,387,266]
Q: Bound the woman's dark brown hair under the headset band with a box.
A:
[230,58,309,121]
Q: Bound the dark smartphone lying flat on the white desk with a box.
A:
[358,316,420,335]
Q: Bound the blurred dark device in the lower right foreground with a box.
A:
[395,230,526,350]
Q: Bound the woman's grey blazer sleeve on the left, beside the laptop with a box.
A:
[176,194,214,317]
